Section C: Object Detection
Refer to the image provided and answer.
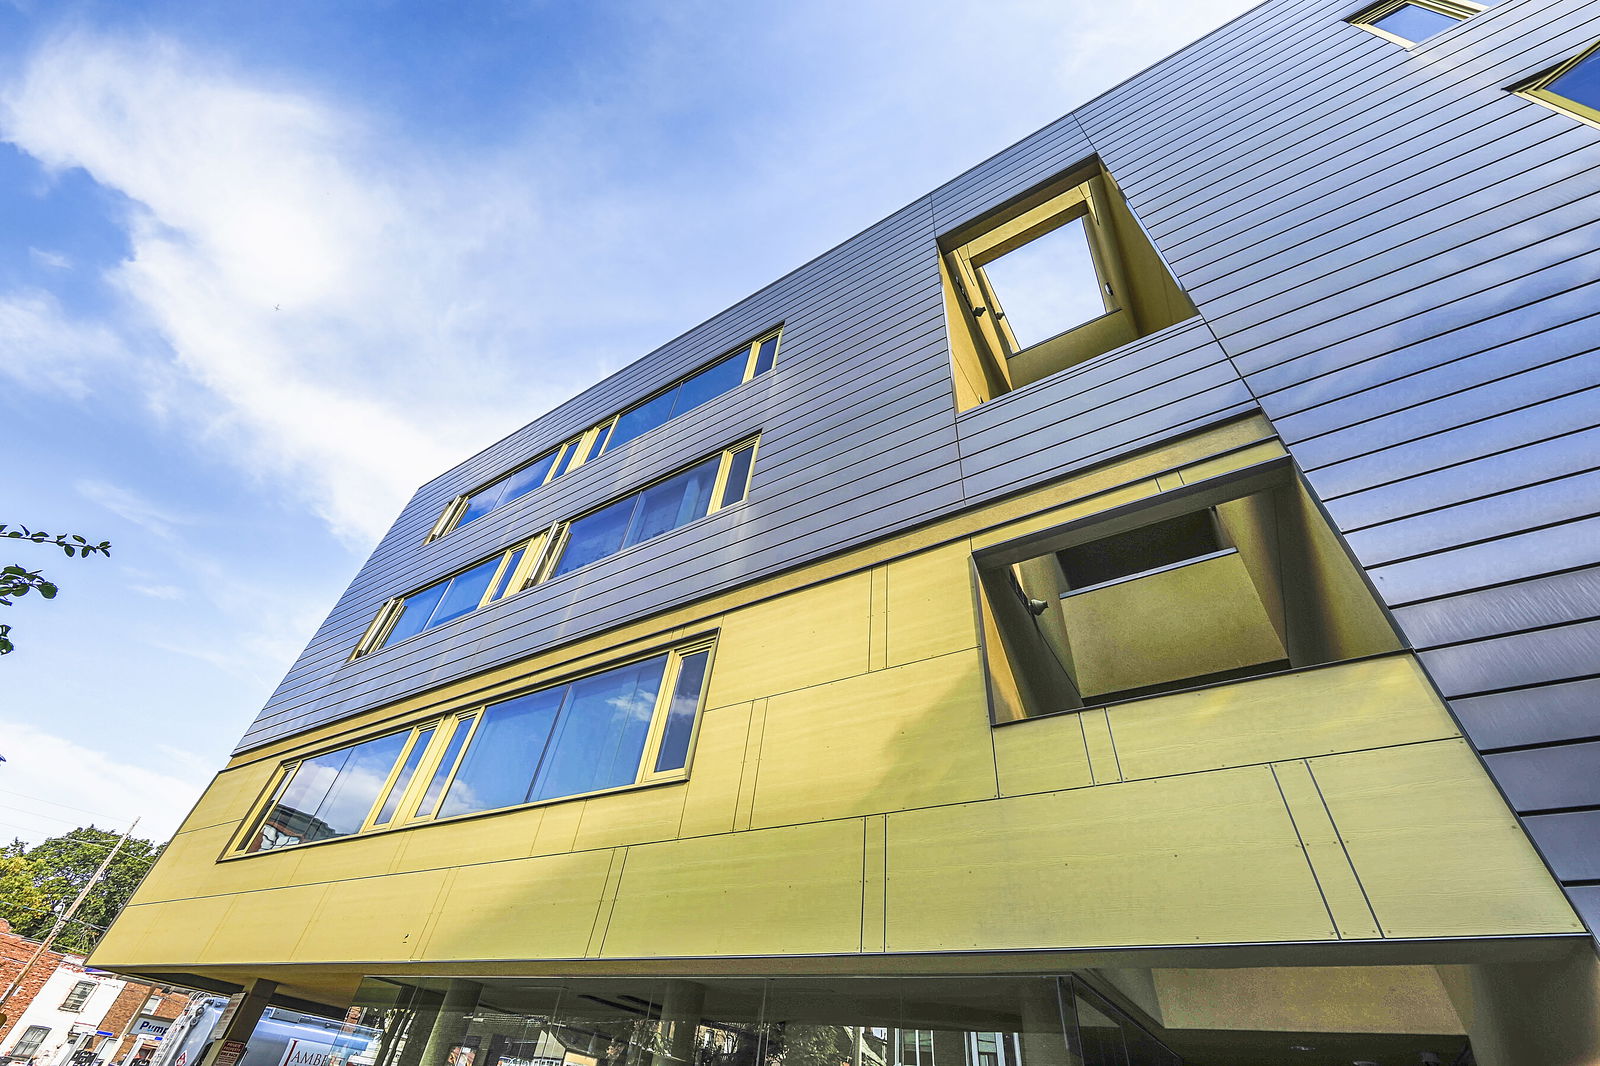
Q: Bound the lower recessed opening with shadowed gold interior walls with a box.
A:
[976,461,1400,719]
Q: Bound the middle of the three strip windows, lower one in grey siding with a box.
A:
[350,437,758,659]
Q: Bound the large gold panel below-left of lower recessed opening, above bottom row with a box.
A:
[750,651,997,828]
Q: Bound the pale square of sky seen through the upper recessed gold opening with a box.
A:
[982,216,1106,347]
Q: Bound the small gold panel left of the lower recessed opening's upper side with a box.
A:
[883,541,978,666]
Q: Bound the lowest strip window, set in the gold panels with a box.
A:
[235,639,714,855]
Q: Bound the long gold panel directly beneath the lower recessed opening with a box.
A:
[1107,655,1456,778]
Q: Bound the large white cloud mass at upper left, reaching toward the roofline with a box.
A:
[0,35,572,539]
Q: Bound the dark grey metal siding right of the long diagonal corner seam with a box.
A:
[1078,0,1600,912]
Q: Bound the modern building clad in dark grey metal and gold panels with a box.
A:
[84,0,1600,1066]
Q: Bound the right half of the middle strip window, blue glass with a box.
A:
[549,440,755,578]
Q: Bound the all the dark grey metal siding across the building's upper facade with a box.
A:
[242,0,1600,912]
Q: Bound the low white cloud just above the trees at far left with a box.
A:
[0,719,209,842]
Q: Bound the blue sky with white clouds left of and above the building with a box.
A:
[0,0,1250,839]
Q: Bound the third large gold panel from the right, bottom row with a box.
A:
[603,820,862,957]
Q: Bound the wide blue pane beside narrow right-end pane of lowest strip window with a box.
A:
[534,655,667,799]
